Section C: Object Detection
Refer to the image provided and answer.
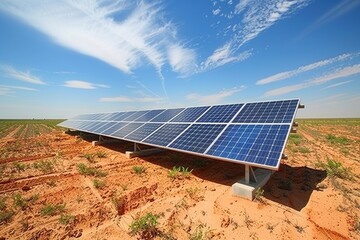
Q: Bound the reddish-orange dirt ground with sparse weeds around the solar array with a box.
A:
[0,120,360,240]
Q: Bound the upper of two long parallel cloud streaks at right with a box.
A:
[256,54,354,85]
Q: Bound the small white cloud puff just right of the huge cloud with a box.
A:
[168,44,197,76]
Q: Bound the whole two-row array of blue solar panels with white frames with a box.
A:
[59,99,299,169]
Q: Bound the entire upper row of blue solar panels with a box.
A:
[69,100,298,123]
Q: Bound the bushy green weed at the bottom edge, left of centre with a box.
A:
[129,213,159,239]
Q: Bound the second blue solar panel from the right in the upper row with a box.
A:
[197,104,243,123]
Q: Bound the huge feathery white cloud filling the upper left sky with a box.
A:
[0,0,181,73]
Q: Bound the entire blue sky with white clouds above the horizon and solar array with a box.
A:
[0,0,360,118]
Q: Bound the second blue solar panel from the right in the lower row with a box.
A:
[169,124,226,153]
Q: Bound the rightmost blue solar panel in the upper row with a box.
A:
[233,100,299,123]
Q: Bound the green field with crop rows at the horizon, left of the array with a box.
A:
[0,119,64,138]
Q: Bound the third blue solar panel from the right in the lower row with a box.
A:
[143,124,190,146]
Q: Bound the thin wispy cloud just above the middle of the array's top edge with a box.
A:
[186,86,245,104]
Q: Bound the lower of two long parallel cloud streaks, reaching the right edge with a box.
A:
[265,64,360,96]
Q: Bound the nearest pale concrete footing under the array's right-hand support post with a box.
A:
[232,168,274,200]
